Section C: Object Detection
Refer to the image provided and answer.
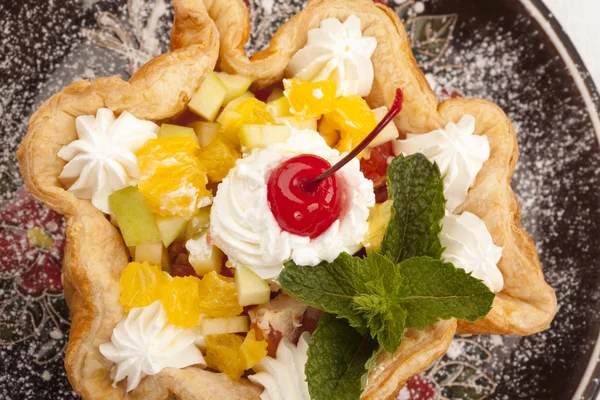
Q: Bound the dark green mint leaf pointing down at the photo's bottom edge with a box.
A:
[305,314,378,400]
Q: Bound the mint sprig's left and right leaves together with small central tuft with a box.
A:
[278,253,494,353]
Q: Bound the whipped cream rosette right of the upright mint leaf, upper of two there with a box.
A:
[394,115,490,212]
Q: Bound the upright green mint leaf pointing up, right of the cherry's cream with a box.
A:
[381,153,446,264]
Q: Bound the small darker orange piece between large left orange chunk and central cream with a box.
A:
[200,135,242,182]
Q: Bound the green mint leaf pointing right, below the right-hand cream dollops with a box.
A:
[398,257,495,329]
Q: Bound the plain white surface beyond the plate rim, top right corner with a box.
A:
[545,0,600,85]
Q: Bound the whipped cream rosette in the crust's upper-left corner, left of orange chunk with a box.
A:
[58,108,159,214]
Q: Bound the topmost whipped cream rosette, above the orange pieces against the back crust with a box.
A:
[286,15,377,97]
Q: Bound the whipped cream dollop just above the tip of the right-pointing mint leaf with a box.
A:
[440,211,504,293]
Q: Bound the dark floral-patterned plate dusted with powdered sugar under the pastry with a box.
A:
[0,0,600,399]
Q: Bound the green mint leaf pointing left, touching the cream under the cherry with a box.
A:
[277,253,367,333]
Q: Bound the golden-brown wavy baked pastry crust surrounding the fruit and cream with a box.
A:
[18,0,556,400]
